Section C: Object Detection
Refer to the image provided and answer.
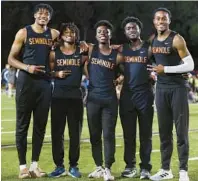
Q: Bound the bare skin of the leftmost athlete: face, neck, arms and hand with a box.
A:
[8,9,59,74]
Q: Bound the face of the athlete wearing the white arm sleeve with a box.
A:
[153,11,171,32]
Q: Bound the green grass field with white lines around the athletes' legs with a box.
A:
[1,94,198,181]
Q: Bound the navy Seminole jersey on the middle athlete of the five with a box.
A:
[88,45,118,100]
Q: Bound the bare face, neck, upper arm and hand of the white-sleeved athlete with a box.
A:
[148,11,190,74]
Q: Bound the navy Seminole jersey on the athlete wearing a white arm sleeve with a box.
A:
[152,31,186,88]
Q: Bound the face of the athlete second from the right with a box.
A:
[124,22,141,40]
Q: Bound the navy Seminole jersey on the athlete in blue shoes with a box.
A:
[53,47,83,98]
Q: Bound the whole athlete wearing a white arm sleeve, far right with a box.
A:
[148,8,194,181]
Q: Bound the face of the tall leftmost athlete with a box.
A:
[34,9,50,26]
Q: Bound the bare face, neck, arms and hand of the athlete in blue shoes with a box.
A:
[49,28,88,78]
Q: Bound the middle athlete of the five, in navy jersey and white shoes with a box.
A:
[85,20,123,181]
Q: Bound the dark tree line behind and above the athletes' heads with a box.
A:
[1,1,198,69]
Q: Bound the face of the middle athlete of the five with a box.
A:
[96,26,111,43]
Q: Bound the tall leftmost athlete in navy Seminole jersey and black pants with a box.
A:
[8,4,59,179]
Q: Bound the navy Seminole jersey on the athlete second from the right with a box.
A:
[122,43,151,91]
